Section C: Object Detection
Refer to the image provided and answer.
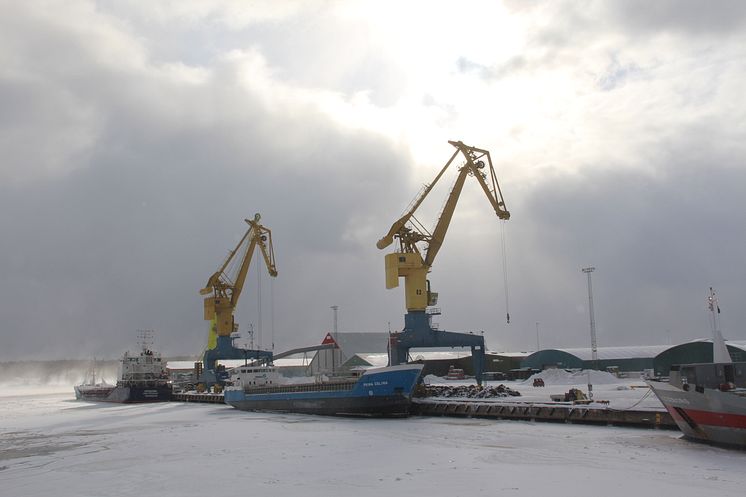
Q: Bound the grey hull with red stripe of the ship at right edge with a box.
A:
[648,381,746,449]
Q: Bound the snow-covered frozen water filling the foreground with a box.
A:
[0,386,746,497]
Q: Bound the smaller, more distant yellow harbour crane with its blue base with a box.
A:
[199,214,277,386]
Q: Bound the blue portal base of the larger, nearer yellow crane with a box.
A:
[389,311,484,385]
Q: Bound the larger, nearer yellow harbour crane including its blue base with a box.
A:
[376,141,510,385]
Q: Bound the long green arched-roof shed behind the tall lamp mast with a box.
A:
[521,345,670,372]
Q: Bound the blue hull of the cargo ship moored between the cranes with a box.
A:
[224,364,422,417]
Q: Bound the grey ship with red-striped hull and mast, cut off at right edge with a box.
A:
[648,288,746,449]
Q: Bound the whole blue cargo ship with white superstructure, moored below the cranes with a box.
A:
[224,364,423,417]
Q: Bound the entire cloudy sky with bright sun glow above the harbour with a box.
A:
[0,0,746,360]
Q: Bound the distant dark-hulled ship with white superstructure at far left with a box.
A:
[75,330,171,403]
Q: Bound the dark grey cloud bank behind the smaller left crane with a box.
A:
[0,116,410,357]
